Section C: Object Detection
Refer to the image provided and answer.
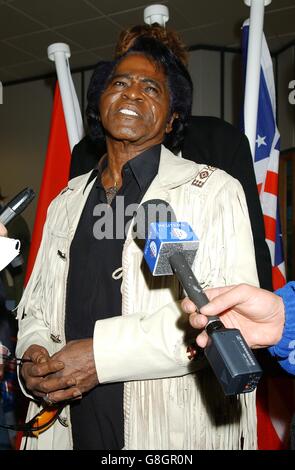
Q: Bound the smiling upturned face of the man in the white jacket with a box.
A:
[99,54,175,148]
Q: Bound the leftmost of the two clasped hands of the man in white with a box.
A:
[21,344,79,400]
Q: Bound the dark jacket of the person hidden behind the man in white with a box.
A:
[70,116,273,290]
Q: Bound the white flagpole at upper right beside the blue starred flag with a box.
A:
[244,0,272,159]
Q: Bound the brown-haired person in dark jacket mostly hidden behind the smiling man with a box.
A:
[70,24,273,290]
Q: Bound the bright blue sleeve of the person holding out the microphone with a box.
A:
[269,281,295,375]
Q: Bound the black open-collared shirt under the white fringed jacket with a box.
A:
[65,145,161,450]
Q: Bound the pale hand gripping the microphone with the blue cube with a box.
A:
[181,284,285,348]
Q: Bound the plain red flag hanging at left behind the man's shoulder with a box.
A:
[25,82,71,284]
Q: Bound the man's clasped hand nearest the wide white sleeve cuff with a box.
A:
[44,338,98,402]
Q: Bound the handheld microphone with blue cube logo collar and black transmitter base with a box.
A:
[144,200,262,396]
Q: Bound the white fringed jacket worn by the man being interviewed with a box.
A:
[17,146,258,449]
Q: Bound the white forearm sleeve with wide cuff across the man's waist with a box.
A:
[93,302,201,383]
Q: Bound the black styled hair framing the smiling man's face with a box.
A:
[86,36,193,153]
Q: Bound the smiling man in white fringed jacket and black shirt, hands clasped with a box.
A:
[17,38,258,450]
